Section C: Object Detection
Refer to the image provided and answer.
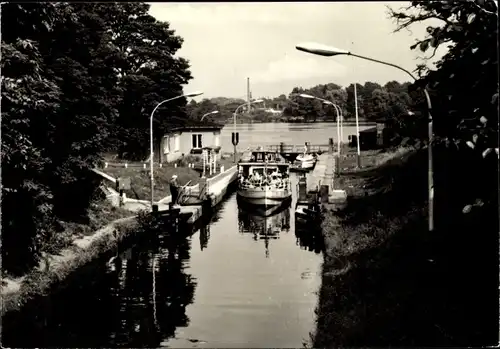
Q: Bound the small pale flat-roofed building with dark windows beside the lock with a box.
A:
[159,124,224,162]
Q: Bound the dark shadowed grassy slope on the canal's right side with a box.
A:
[312,150,498,348]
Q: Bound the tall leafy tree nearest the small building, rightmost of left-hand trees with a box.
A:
[93,3,192,159]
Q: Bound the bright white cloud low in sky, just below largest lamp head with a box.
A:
[249,55,347,83]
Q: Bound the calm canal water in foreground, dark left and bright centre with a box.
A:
[2,175,323,348]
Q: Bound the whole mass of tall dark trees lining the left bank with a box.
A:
[1,2,192,274]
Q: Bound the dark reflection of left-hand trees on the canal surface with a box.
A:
[2,230,196,348]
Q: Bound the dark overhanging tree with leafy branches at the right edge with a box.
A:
[389,0,498,220]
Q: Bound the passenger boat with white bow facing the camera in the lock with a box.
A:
[238,150,292,208]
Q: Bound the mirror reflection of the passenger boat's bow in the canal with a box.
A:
[238,208,290,257]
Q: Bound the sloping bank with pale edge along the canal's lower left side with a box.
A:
[0,200,138,316]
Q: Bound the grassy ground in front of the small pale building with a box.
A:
[102,156,238,200]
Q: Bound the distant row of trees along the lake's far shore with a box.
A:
[188,81,419,123]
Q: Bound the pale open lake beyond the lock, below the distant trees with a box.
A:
[221,122,373,151]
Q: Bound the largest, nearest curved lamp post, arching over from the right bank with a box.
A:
[295,43,434,231]
